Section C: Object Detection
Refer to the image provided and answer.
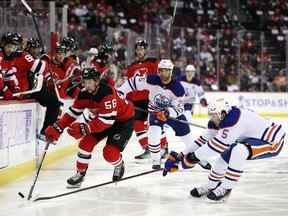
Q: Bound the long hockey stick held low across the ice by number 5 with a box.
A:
[34,168,163,202]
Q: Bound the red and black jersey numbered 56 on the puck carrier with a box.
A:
[58,82,134,133]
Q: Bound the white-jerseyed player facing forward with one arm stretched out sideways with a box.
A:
[118,59,205,169]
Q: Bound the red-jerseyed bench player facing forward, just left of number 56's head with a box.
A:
[46,44,81,98]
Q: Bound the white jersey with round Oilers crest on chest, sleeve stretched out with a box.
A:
[118,75,185,116]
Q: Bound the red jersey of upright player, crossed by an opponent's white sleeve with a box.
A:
[126,58,159,101]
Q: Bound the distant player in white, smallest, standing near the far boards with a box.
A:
[180,65,208,122]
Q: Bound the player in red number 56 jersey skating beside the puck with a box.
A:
[46,68,134,187]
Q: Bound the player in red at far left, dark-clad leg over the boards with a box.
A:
[1,32,61,138]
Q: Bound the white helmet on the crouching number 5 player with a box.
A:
[208,98,231,120]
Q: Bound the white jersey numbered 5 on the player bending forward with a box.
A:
[183,107,285,154]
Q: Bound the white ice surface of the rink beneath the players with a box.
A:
[0,120,288,216]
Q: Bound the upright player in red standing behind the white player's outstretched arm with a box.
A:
[126,39,168,159]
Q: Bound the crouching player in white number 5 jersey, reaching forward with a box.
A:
[163,99,285,201]
